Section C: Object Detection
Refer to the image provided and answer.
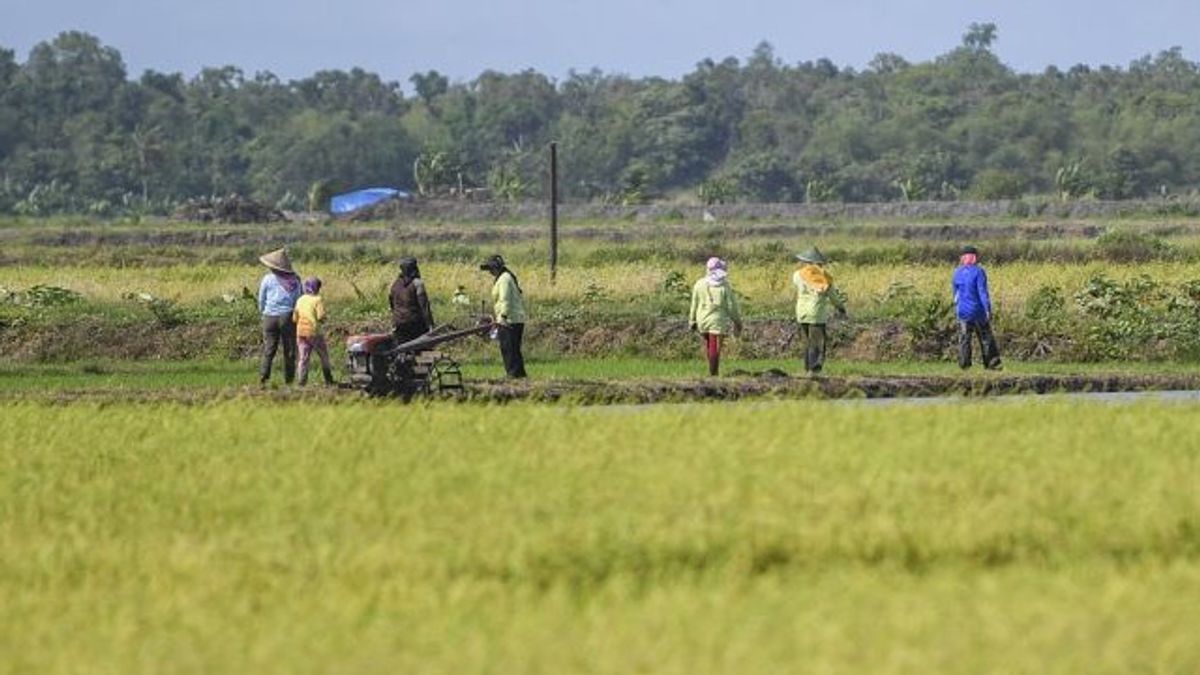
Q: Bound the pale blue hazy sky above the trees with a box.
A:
[0,0,1200,85]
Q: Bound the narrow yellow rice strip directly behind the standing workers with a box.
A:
[7,259,1200,316]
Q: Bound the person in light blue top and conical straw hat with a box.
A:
[258,249,300,384]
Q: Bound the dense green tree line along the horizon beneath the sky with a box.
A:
[0,24,1200,215]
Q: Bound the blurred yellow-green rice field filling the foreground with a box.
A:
[0,402,1200,673]
